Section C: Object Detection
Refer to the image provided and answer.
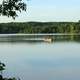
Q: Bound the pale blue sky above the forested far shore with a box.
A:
[0,0,80,23]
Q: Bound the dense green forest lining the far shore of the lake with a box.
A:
[0,22,80,34]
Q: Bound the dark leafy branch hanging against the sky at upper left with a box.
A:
[0,0,26,19]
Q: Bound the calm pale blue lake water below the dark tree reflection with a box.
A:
[0,36,80,80]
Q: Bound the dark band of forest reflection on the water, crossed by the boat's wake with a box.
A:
[0,35,80,43]
